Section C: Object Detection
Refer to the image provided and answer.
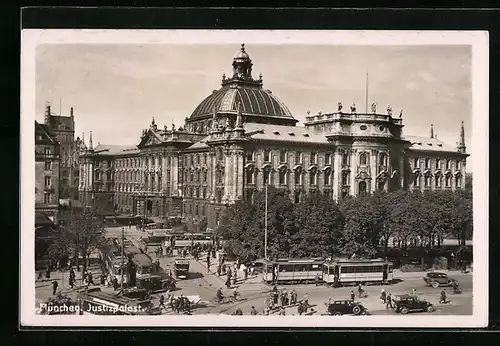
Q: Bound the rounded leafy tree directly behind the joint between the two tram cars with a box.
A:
[289,193,344,257]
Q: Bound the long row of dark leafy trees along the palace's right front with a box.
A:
[219,188,472,259]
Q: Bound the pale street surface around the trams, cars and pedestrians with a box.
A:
[36,227,472,315]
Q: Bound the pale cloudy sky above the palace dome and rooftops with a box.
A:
[35,44,472,152]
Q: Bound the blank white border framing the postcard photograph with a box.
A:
[20,29,489,328]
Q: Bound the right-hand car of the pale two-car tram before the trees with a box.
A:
[323,258,393,287]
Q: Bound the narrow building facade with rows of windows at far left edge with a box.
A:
[35,121,60,222]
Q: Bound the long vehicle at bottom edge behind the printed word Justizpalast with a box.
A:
[77,287,161,315]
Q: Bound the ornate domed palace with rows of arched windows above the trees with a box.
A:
[79,45,468,228]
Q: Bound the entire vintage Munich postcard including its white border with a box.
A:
[20,30,489,328]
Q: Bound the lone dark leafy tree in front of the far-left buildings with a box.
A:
[53,209,106,271]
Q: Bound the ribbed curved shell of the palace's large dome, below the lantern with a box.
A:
[191,86,293,120]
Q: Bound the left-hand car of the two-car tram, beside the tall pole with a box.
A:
[264,258,325,284]
